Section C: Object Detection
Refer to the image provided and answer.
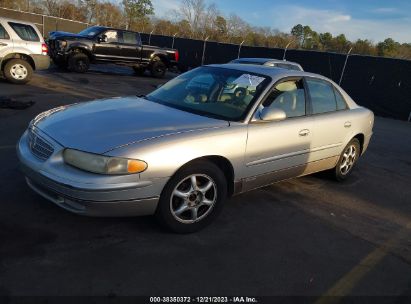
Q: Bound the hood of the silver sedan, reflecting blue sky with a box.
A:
[32,97,229,154]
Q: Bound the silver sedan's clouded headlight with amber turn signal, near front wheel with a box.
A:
[63,149,147,174]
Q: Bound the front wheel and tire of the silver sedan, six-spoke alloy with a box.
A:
[155,161,227,233]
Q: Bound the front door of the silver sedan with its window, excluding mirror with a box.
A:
[244,78,313,190]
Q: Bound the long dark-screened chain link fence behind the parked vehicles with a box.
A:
[0,8,411,120]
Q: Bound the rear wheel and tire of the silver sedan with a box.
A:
[333,138,361,181]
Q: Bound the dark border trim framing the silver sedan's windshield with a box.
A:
[145,66,272,122]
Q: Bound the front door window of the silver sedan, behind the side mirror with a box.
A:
[262,80,305,118]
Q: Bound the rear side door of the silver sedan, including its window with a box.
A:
[306,77,352,160]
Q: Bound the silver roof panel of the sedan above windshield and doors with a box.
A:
[208,63,326,82]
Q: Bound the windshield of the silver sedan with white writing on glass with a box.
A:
[146,67,270,121]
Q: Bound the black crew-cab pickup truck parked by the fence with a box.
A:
[47,26,178,77]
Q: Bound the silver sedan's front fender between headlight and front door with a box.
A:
[108,123,247,180]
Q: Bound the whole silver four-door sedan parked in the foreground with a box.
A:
[17,64,374,233]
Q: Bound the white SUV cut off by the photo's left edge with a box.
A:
[0,17,50,84]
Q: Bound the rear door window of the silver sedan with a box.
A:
[307,78,337,114]
